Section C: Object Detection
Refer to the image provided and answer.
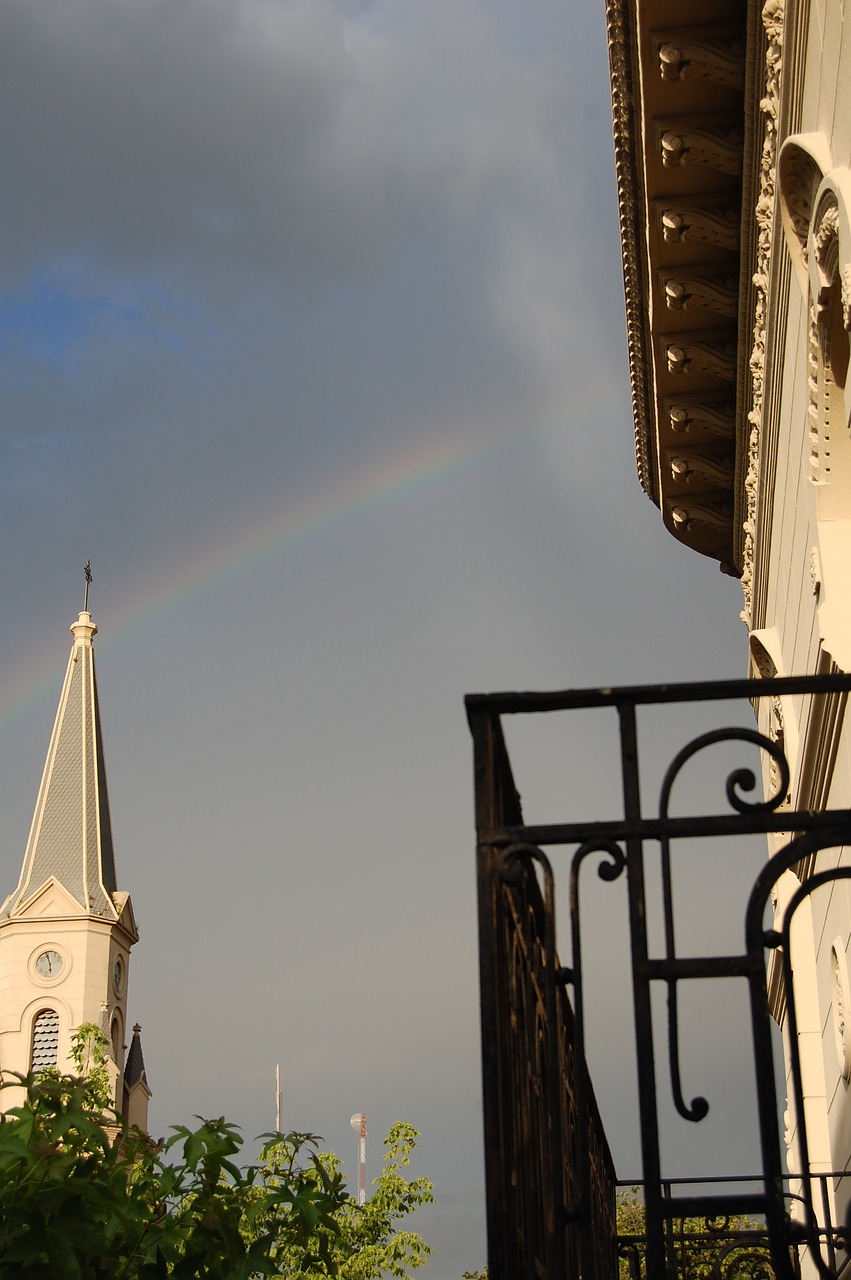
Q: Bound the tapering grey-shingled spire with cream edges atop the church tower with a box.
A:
[0,609,120,920]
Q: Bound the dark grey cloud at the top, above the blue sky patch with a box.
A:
[0,0,588,298]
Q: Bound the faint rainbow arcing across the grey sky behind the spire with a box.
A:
[0,434,518,732]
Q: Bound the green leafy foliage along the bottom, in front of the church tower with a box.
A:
[0,1073,431,1280]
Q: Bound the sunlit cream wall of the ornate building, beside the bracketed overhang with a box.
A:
[754,0,851,1213]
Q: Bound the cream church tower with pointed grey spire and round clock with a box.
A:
[0,599,151,1128]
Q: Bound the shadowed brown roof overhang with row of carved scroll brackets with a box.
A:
[607,0,774,576]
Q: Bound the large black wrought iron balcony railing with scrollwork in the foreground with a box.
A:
[467,676,851,1280]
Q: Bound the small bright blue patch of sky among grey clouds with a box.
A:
[0,270,222,370]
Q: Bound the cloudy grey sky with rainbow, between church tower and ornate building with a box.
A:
[0,0,761,1280]
